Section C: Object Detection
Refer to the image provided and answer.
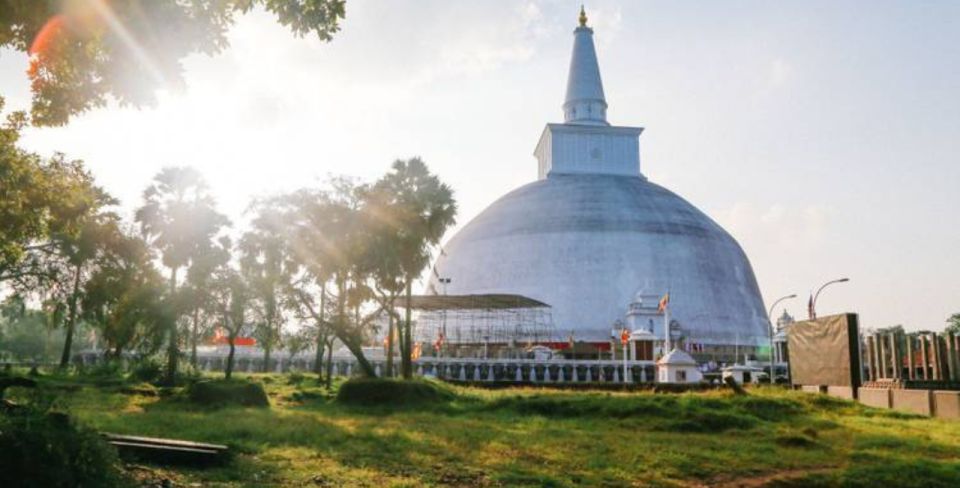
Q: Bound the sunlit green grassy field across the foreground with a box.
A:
[8,375,960,487]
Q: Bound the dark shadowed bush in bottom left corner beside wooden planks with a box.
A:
[0,407,130,488]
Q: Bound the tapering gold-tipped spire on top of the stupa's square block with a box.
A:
[563,5,610,125]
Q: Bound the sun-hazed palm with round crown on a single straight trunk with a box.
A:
[136,167,229,384]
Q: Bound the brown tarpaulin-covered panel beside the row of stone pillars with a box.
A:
[787,313,860,388]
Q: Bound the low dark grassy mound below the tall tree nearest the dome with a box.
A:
[337,378,456,406]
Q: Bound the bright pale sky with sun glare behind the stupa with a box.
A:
[0,0,960,330]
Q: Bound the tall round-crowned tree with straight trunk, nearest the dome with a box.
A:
[369,158,457,379]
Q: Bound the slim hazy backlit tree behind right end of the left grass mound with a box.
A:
[239,200,295,371]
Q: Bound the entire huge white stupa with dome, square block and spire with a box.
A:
[432,9,767,351]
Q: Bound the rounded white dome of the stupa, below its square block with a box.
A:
[436,174,767,346]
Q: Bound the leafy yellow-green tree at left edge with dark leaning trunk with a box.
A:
[0,105,117,368]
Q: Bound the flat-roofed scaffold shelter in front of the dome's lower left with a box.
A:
[411,295,558,348]
